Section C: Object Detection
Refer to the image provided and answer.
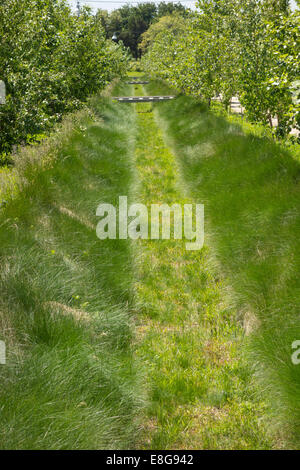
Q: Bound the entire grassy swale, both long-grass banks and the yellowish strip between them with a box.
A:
[0,79,300,450]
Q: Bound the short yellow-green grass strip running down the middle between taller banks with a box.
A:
[135,86,271,449]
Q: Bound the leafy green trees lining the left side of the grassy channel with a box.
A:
[0,0,128,162]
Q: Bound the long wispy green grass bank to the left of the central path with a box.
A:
[0,82,143,449]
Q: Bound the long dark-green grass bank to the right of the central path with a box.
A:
[147,83,300,448]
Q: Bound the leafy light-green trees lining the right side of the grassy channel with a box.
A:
[142,0,300,137]
